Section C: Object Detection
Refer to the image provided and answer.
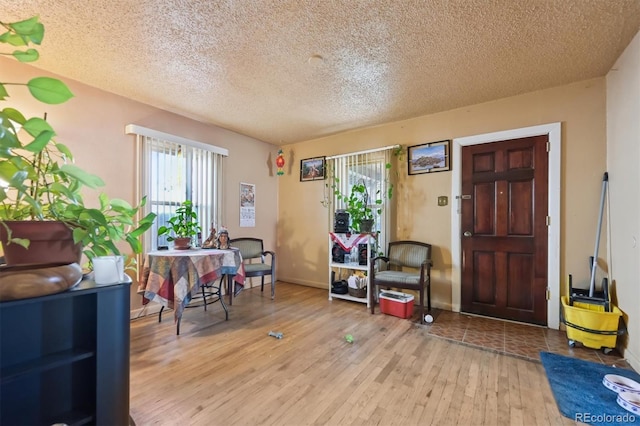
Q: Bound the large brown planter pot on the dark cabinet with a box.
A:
[0,221,82,266]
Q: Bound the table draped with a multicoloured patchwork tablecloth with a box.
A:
[138,247,245,334]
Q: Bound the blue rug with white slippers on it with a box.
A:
[540,352,640,426]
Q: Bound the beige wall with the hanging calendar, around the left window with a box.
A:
[0,58,278,309]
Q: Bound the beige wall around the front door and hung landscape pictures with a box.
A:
[278,78,606,316]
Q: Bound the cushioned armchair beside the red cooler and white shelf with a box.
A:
[369,241,432,324]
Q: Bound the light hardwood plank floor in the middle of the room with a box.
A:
[130,283,575,426]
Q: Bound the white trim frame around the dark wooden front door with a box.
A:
[451,123,562,330]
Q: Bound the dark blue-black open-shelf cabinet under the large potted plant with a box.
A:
[0,280,131,426]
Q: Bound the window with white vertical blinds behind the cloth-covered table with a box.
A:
[127,125,228,252]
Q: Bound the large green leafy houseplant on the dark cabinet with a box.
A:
[0,17,155,263]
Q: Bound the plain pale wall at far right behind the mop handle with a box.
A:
[607,33,640,371]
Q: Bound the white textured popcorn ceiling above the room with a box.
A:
[0,0,640,144]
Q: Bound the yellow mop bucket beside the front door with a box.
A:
[562,296,622,353]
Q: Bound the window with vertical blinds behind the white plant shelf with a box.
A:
[327,148,392,251]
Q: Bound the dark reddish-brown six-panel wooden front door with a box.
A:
[461,135,548,325]
